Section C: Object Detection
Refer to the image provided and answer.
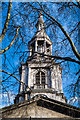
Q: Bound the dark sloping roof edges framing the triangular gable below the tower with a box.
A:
[2,95,80,118]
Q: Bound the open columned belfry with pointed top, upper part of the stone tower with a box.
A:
[28,11,53,56]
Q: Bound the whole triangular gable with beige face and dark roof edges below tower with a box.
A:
[2,97,80,119]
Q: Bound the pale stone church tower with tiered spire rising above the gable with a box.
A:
[15,12,66,103]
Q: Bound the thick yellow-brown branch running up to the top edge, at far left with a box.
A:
[0,0,12,43]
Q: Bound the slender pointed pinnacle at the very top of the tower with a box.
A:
[36,11,44,31]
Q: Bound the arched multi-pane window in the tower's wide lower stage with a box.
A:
[36,71,45,85]
